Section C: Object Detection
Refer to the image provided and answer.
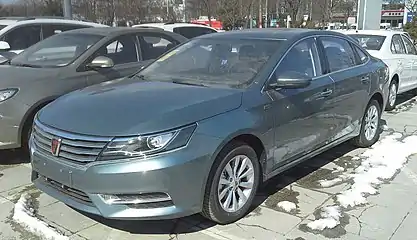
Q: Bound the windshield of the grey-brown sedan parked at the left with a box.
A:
[11,33,103,67]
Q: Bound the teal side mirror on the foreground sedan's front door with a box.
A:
[269,71,311,89]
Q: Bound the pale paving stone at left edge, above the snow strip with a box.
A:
[0,165,31,193]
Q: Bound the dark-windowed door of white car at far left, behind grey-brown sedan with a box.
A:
[4,24,41,54]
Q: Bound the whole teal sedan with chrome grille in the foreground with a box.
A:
[30,29,389,224]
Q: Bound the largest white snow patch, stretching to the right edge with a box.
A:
[337,133,417,208]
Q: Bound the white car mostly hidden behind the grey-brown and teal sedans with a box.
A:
[132,23,219,39]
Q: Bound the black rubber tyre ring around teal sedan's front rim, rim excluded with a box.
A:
[209,145,260,224]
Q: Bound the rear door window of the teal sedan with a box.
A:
[320,37,356,72]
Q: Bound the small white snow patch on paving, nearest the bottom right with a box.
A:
[307,206,342,231]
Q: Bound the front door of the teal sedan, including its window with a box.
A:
[268,38,334,168]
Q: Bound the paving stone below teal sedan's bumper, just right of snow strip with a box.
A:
[38,202,96,233]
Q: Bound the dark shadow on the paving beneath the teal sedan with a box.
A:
[70,139,370,235]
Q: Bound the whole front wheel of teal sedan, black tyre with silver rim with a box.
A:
[202,142,261,224]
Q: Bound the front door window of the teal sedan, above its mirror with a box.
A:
[275,38,321,78]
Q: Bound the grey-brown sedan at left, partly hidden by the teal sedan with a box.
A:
[0,28,187,149]
